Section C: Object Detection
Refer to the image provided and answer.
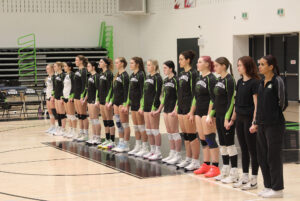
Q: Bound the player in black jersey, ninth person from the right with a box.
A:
[110,57,130,153]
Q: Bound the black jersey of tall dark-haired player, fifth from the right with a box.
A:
[178,69,198,114]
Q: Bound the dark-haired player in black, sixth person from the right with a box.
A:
[154,61,182,165]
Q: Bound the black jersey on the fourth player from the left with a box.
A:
[74,68,88,99]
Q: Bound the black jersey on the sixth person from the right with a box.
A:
[161,76,178,113]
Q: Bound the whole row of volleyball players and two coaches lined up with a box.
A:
[47,51,286,197]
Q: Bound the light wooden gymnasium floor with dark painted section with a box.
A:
[0,103,300,201]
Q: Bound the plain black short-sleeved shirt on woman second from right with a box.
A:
[235,78,259,116]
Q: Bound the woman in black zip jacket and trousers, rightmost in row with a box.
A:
[250,55,288,198]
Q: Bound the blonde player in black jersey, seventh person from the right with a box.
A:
[139,60,162,160]
